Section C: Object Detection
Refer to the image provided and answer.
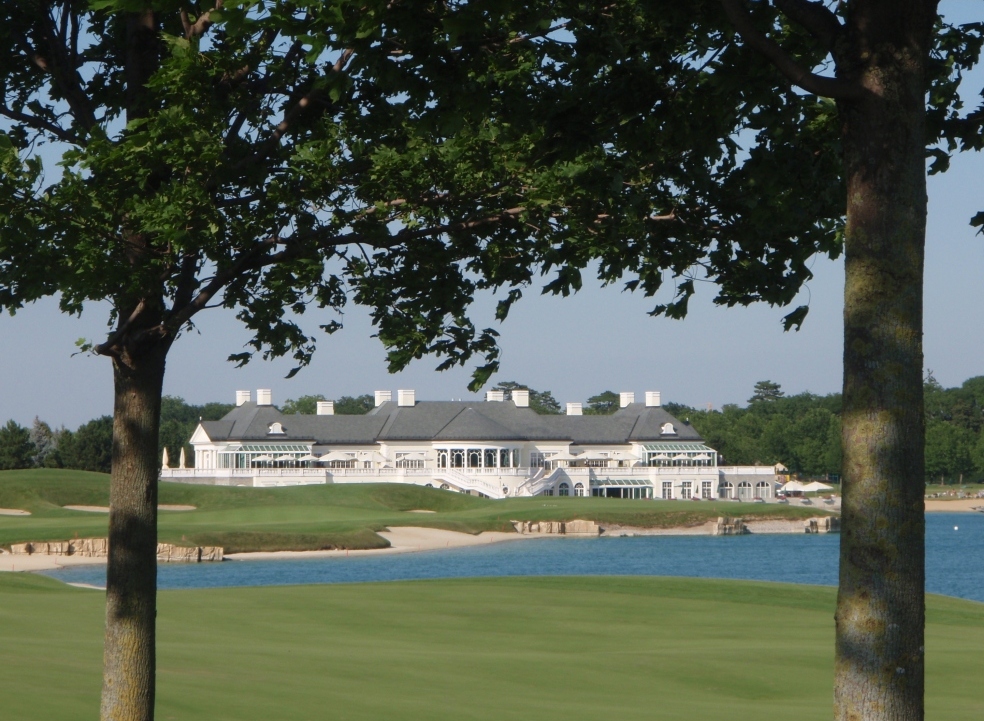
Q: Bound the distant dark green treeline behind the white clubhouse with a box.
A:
[7,373,984,483]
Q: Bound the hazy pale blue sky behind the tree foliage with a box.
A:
[0,3,984,428]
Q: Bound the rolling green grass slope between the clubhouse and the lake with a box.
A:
[0,470,836,553]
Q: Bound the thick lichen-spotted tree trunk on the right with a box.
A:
[834,0,935,721]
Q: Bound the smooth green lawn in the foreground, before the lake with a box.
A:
[0,574,984,721]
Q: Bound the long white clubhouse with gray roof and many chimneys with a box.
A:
[161,389,776,500]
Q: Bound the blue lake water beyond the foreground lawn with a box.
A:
[40,513,984,602]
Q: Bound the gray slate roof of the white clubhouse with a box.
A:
[202,401,702,446]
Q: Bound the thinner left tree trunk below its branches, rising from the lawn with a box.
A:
[100,343,166,721]
